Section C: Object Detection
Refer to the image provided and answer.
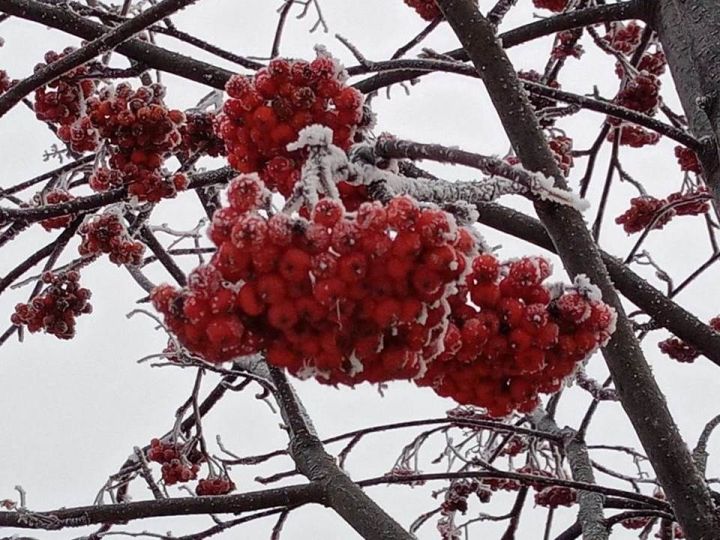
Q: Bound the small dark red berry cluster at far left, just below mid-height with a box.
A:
[10,271,92,339]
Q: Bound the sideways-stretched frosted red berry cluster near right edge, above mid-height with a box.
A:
[615,186,710,234]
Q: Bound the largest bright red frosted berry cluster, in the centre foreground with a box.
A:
[153,175,475,385]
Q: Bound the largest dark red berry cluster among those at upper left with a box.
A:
[87,83,187,202]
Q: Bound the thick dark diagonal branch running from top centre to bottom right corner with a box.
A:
[437,0,720,538]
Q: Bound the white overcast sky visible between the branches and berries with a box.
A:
[0,0,720,540]
